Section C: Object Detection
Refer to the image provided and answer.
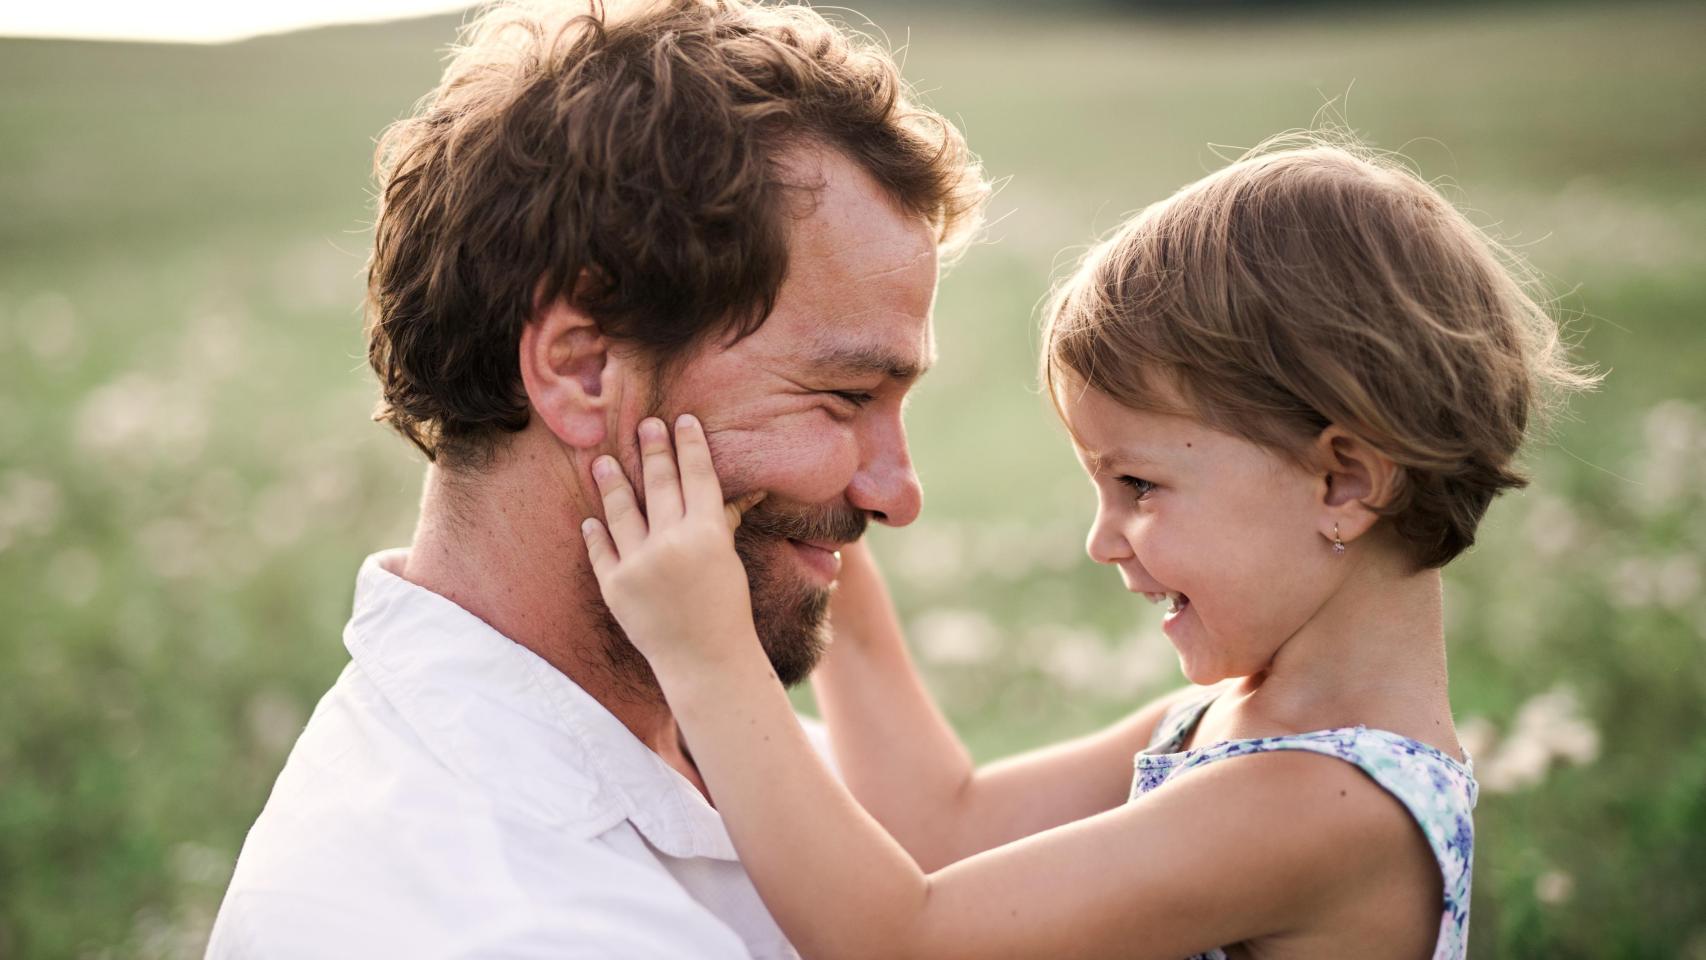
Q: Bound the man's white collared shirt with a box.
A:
[208,551,822,960]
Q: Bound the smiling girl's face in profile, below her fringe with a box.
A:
[1063,387,1344,684]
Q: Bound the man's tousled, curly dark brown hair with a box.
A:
[367,0,988,466]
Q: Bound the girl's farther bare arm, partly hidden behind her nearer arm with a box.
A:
[812,544,1201,870]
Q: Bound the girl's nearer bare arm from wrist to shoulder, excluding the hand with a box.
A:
[659,638,1392,960]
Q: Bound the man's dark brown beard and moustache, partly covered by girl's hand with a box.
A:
[592,500,870,699]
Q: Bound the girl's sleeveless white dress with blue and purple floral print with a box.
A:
[1131,691,1479,960]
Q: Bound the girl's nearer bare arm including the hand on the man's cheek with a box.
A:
[582,418,1436,960]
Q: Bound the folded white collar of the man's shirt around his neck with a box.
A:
[343,549,735,859]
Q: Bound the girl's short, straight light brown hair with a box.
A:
[1042,135,1597,566]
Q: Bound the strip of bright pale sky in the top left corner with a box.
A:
[0,0,473,43]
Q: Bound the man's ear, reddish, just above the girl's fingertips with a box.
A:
[520,297,612,448]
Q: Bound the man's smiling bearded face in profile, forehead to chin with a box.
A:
[624,152,937,684]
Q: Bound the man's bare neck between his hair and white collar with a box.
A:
[403,457,705,793]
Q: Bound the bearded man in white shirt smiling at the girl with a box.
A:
[210,0,986,958]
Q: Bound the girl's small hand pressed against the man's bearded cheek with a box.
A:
[580,414,757,672]
